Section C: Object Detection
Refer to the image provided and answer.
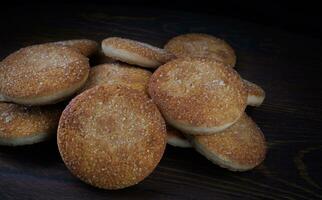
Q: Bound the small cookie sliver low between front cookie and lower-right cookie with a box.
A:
[167,125,191,148]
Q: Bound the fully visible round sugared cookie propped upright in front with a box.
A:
[57,85,166,189]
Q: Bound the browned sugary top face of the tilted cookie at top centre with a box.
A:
[102,37,174,64]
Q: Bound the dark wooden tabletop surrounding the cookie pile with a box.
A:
[0,5,322,200]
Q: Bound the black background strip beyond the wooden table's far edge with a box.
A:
[0,0,322,38]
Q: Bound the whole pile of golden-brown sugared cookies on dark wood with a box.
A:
[0,34,266,189]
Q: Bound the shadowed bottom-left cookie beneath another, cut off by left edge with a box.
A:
[0,103,63,146]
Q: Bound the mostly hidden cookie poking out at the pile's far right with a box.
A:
[244,79,266,106]
